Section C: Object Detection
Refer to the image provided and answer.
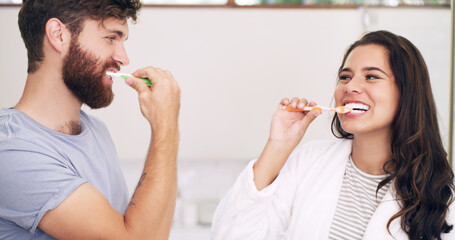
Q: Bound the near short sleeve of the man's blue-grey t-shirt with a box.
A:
[0,139,86,233]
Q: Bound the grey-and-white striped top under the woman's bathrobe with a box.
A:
[329,158,390,240]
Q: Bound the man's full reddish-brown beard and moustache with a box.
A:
[62,39,120,109]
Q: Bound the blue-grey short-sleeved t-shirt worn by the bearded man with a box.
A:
[0,108,128,240]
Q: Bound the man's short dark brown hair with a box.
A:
[18,0,142,73]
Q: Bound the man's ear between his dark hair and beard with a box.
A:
[46,18,71,53]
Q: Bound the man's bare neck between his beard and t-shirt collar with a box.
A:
[14,64,82,135]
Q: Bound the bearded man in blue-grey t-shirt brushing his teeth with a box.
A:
[0,0,180,240]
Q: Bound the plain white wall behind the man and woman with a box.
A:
[0,8,450,163]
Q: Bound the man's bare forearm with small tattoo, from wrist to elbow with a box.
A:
[125,131,179,239]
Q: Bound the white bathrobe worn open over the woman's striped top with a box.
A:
[211,140,455,240]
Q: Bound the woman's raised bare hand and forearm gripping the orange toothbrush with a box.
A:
[253,98,321,190]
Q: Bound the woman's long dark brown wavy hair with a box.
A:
[332,31,454,240]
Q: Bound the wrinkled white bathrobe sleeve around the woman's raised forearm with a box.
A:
[211,146,304,240]
